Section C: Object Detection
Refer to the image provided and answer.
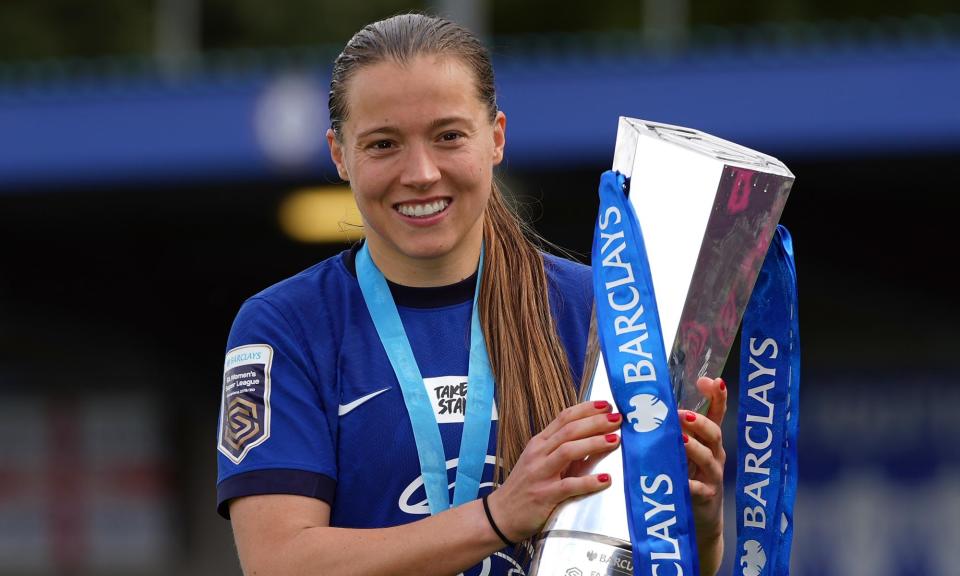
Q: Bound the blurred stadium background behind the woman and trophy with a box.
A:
[0,0,960,576]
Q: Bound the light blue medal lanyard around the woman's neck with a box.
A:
[357,243,493,514]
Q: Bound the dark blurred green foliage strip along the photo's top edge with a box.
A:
[0,0,957,62]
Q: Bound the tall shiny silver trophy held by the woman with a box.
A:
[530,117,794,576]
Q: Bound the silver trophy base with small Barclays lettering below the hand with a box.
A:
[530,530,633,576]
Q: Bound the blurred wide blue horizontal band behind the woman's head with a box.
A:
[0,39,960,191]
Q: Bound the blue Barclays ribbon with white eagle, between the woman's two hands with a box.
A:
[592,171,700,576]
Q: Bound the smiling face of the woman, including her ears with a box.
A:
[327,56,506,276]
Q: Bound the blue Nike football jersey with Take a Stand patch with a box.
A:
[217,248,593,575]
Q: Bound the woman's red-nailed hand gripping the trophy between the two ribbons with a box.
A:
[680,377,727,574]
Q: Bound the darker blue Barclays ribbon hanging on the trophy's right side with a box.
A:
[734,226,800,576]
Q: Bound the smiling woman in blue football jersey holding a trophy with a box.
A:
[218,15,726,575]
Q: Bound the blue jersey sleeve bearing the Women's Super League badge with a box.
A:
[217,298,337,518]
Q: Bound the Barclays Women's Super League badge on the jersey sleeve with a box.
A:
[217,344,273,464]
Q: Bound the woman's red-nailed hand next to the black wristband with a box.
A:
[487,400,623,542]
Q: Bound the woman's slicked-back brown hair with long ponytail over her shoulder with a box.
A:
[329,14,575,484]
